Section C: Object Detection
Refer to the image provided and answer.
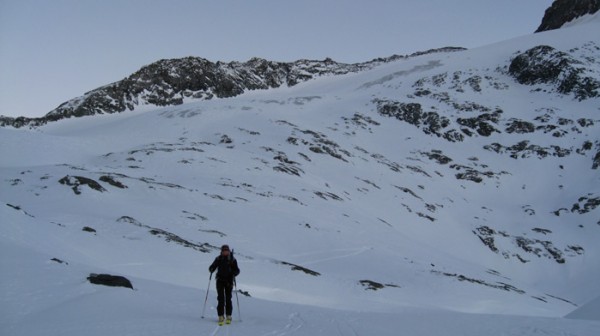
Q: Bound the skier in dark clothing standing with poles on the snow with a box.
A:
[208,245,240,325]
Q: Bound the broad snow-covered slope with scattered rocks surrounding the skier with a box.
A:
[0,11,600,335]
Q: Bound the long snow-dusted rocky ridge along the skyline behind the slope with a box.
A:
[0,47,464,128]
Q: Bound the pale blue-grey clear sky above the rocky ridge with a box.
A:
[0,0,552,117]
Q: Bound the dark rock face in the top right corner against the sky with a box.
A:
[535,0,600,33]
